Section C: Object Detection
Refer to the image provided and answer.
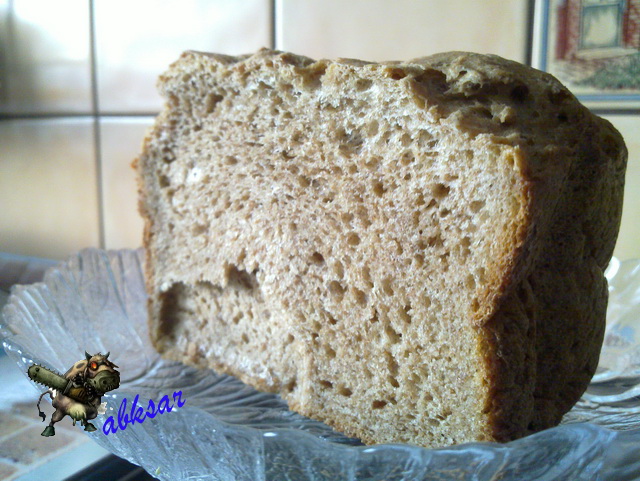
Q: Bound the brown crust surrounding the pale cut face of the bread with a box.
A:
[134,49,627,446]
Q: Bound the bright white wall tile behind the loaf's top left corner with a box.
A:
[95,0,271,113]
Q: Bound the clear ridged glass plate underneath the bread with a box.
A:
[0,249,640,481]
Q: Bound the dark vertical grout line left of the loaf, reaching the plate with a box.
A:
[89,0,106,249]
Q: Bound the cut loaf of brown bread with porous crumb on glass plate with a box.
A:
[134,49,627,446]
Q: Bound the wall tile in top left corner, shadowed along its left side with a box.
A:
[0,0,91,114]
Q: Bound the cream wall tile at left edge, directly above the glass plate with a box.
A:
[0,118,99,259]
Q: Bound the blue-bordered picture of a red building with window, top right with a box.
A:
[532,0,640,110]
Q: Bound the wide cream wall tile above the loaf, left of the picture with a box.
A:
[276,0,528,62]
